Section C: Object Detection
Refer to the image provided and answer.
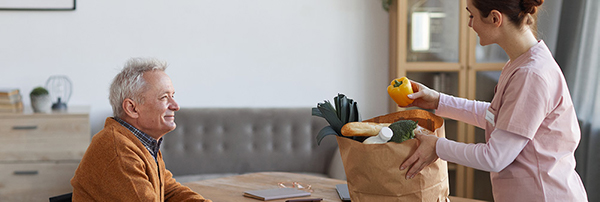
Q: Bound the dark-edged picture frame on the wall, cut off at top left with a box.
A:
[0,0,76,11]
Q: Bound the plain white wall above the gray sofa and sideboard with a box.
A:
[0,0,389,136]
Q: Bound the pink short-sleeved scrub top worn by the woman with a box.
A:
[485,41,587,202]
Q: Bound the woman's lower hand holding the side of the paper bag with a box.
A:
[400,133,438,179]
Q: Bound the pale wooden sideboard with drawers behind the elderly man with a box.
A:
[0,106,91,201]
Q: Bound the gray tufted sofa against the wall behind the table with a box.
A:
[161,108,345,182]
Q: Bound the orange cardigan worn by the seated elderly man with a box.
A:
[71,117,210,202]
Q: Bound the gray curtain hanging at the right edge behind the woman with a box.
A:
[555,0,600,201]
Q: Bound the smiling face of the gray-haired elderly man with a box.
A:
[137,71,179,139]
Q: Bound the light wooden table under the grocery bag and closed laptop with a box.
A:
[184,172,482,202]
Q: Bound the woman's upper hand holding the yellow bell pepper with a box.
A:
[405,80,440,109]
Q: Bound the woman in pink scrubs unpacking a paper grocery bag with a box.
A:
[400,0,587,202]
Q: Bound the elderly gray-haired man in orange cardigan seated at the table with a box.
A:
[71,58,210,202]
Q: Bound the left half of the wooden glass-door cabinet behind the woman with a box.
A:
[390,0,469,196]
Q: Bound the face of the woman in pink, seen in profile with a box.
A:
[467,0,494,46]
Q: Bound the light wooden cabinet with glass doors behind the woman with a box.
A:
[389,0,508,200]
